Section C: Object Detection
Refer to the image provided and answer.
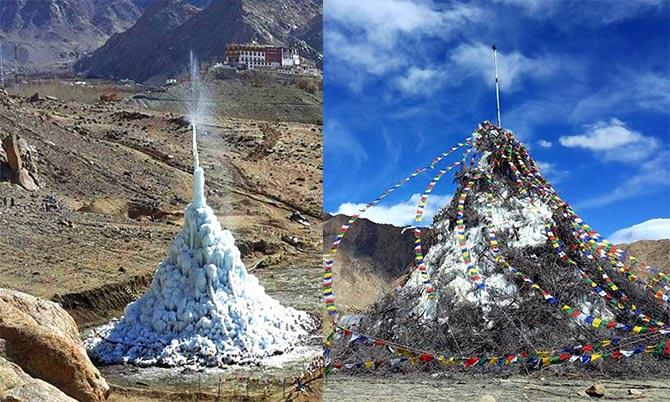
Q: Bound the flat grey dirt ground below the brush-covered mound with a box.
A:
[323,374,670,402]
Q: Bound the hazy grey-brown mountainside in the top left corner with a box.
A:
[0,0,141,71]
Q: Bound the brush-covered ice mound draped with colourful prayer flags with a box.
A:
[334,122,670,371]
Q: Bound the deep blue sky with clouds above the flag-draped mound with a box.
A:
[324,0,670,241]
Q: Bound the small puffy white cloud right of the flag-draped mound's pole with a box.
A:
[558,119,658,162]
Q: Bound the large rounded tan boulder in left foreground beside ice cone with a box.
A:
[0,289,109,402]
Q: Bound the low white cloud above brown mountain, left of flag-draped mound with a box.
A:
[334,193,452,226]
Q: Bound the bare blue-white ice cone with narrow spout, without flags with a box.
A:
[86,168,313,366]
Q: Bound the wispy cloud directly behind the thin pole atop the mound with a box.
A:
[450,43,560,92]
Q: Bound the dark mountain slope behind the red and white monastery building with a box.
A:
[75,0,322,82]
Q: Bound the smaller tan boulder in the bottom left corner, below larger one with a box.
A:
[0,357,75,402]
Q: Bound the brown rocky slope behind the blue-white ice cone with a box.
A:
[0,77,322,400]
